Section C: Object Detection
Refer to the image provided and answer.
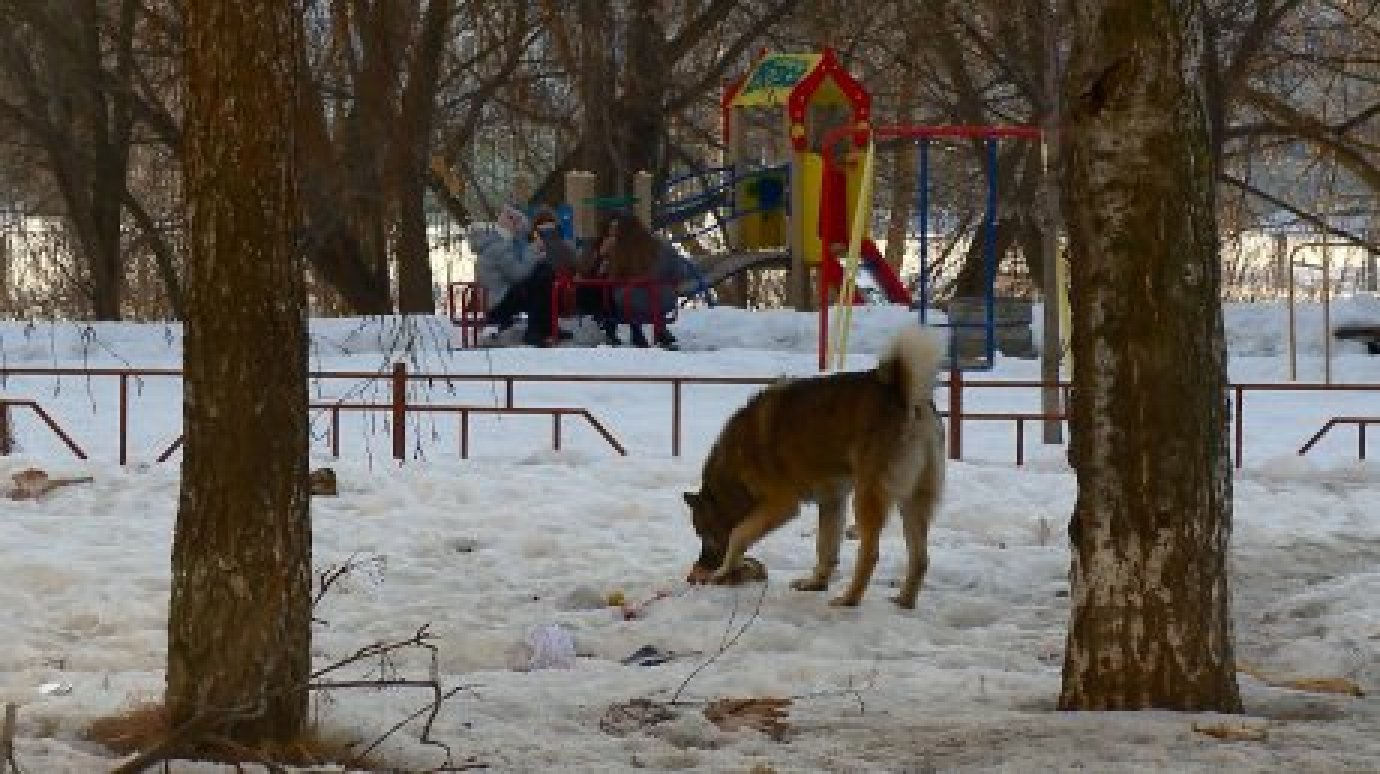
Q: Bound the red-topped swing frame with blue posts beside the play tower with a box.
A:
[818,124,1037,371]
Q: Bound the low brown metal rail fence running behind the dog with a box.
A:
[0,363,1380,468]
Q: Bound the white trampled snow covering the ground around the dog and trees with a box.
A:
[0,299,1380,773]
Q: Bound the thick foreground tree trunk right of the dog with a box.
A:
[1060,0,1241,712]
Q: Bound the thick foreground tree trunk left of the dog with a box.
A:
[166,0,312,752]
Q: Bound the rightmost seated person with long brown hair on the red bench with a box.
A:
[575,212,684,348]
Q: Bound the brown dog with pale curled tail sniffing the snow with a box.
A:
[684,326,944,608]
